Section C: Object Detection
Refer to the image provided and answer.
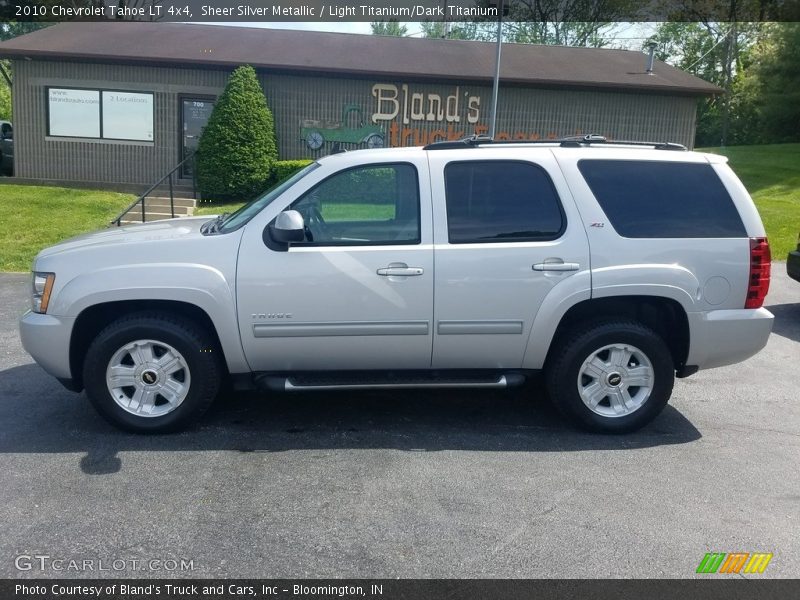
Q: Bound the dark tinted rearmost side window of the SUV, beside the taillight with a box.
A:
[578,160,747,238]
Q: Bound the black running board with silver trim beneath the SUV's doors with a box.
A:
[256,373,525,392]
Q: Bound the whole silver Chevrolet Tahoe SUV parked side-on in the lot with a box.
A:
[21,137,773,432]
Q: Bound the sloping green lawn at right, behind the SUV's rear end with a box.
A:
[698,144,800,260]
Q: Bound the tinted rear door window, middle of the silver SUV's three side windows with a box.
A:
[444,161,564,244]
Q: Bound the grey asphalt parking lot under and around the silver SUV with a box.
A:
[0,263,800,578]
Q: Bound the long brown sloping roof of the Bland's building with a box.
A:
[0,22,722,95]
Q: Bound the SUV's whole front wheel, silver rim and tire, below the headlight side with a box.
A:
[83,313,222,433]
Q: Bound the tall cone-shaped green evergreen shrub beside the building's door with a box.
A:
[197,66,278,200]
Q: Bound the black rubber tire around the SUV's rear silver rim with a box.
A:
[545,319,675,433]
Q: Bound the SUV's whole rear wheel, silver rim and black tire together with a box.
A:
[546,320,675,433]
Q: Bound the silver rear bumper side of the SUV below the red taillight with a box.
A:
[686,308,774,369]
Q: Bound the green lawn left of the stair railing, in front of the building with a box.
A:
[0,185,135,271]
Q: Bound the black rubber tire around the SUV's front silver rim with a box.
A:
[83,312,223,433]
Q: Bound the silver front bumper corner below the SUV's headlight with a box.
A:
[19,310,75,380]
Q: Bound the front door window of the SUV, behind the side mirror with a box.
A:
[291,163,420,246]
